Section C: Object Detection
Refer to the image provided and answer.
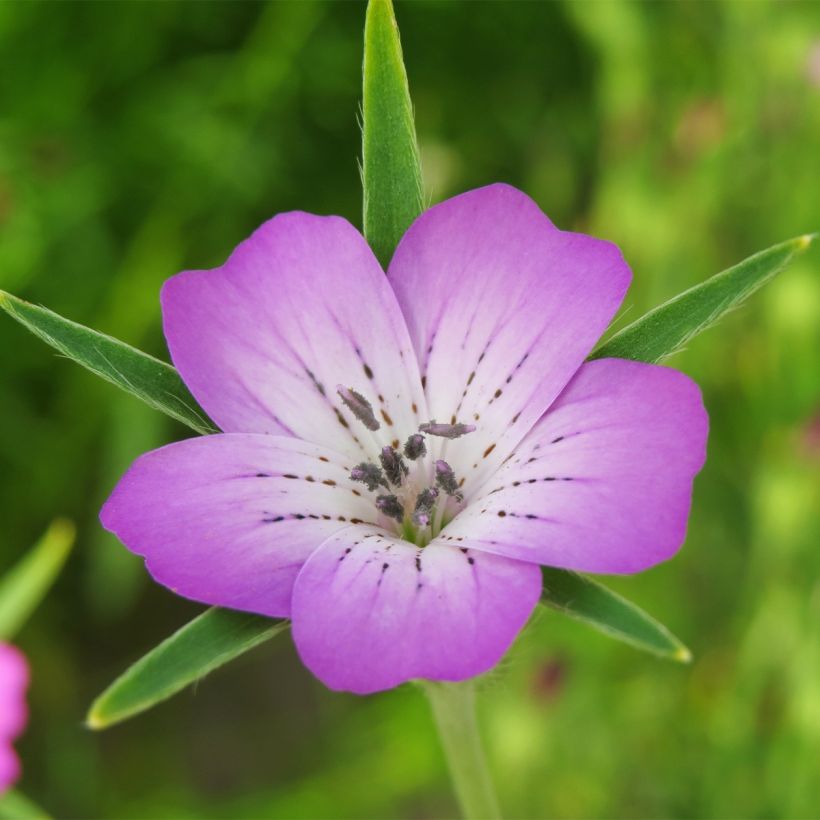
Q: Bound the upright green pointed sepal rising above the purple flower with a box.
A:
[362,0,424,267]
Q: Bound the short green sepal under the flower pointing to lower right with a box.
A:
[541,567,692,663]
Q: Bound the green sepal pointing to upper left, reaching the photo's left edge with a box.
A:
[0,291,216,434]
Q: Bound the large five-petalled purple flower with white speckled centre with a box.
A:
[101,185,708,693]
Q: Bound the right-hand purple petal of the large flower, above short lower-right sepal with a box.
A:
[440,359,709,573]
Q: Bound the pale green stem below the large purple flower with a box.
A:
[419,680,501,820]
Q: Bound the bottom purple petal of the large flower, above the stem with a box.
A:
[293,526,541,694]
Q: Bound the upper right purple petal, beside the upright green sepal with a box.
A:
[388,185,631,489]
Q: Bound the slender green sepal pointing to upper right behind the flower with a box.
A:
[590,235,815,362]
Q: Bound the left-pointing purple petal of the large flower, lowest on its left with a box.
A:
[100,433,382,617]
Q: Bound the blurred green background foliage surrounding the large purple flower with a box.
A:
[0,0,820,818]
